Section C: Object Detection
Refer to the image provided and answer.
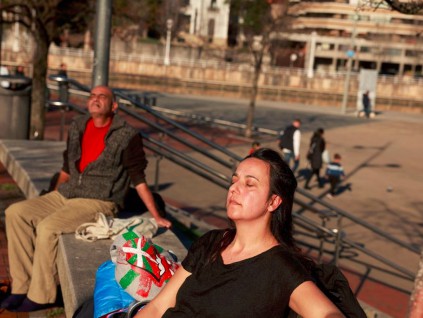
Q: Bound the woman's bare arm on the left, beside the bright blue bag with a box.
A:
[135,266,191,318]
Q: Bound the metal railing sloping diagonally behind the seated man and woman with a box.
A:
[50,76,420,292]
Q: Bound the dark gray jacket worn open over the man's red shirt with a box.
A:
[58,115,142,207]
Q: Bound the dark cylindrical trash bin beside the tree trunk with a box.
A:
[0,76,31,139]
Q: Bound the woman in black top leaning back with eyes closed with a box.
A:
[136,148,343,318]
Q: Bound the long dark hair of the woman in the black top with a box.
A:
[211,148,299,261]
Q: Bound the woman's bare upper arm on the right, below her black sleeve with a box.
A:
[289,281,344,318]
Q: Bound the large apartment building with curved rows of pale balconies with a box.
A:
[285,1,423,76]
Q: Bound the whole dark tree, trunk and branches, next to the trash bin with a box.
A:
[1,0,92,139]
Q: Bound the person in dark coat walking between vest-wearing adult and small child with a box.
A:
[304,128,326,190]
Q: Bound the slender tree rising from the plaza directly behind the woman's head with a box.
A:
[231,0,288,137]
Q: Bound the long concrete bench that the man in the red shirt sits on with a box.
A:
[0,140,187,317]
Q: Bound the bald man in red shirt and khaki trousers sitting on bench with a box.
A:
[0,86,171,312]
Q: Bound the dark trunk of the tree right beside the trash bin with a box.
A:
[30,26,50,140]
